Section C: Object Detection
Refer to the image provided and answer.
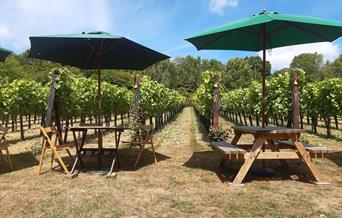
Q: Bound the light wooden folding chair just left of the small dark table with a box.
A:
[38,126,75,175]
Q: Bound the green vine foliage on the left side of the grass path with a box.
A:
[0,68,185,122]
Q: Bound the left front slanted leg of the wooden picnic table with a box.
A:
[232,136,265,186]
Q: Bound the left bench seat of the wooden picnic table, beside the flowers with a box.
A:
[210,142,247,160]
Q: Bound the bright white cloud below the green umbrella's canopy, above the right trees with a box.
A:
[258,42,342,70]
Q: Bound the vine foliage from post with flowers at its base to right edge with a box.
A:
[221,69,342,122]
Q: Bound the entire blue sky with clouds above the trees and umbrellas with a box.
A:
[0,0,342,70]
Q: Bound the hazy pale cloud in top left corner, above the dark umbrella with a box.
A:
[0,0,110,52]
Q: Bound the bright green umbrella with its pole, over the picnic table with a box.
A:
[185,10,342,127]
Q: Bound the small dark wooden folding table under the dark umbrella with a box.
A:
[69,125,129,175]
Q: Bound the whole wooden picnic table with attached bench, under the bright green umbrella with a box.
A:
[212,126,329,186]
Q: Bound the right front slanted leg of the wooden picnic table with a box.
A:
[291,138,330,185]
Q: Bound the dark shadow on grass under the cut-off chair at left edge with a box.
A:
[0,151,38,174]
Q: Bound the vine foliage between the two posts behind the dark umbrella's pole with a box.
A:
[53,68,133,118]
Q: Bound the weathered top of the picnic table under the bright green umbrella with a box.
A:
[233,126,304,134]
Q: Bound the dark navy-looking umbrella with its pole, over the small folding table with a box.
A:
[29,32,169,122]
